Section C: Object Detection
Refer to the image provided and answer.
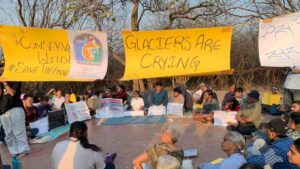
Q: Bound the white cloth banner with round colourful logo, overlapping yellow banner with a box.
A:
[68,31,108,79]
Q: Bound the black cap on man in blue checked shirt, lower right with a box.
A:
[265,119,288,135]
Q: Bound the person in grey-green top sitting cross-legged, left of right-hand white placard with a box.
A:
[193,90,220,123]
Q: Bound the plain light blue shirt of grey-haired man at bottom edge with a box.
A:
[199,153,247,169]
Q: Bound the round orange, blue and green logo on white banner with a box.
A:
[74,33,103,64]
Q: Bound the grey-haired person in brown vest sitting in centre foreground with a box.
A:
[133,126,183,169]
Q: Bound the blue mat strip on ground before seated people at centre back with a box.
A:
[104,115,166,125]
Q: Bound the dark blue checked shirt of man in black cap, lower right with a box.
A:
[247,137,298,169]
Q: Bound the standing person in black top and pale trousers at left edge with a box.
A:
[0,81,30,155]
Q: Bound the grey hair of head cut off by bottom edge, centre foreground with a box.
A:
[156,155,181,169]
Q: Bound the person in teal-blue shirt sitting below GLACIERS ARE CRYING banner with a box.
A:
[151,81,168,107]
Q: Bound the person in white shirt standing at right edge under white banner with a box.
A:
[283,66,300,111]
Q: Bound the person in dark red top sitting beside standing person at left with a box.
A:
[23,94,39,139]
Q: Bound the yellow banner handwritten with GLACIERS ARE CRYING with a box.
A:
[122,27,232,80]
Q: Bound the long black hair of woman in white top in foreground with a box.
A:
[70,121,101,151]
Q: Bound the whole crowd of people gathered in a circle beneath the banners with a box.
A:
[0,68,300,169]
